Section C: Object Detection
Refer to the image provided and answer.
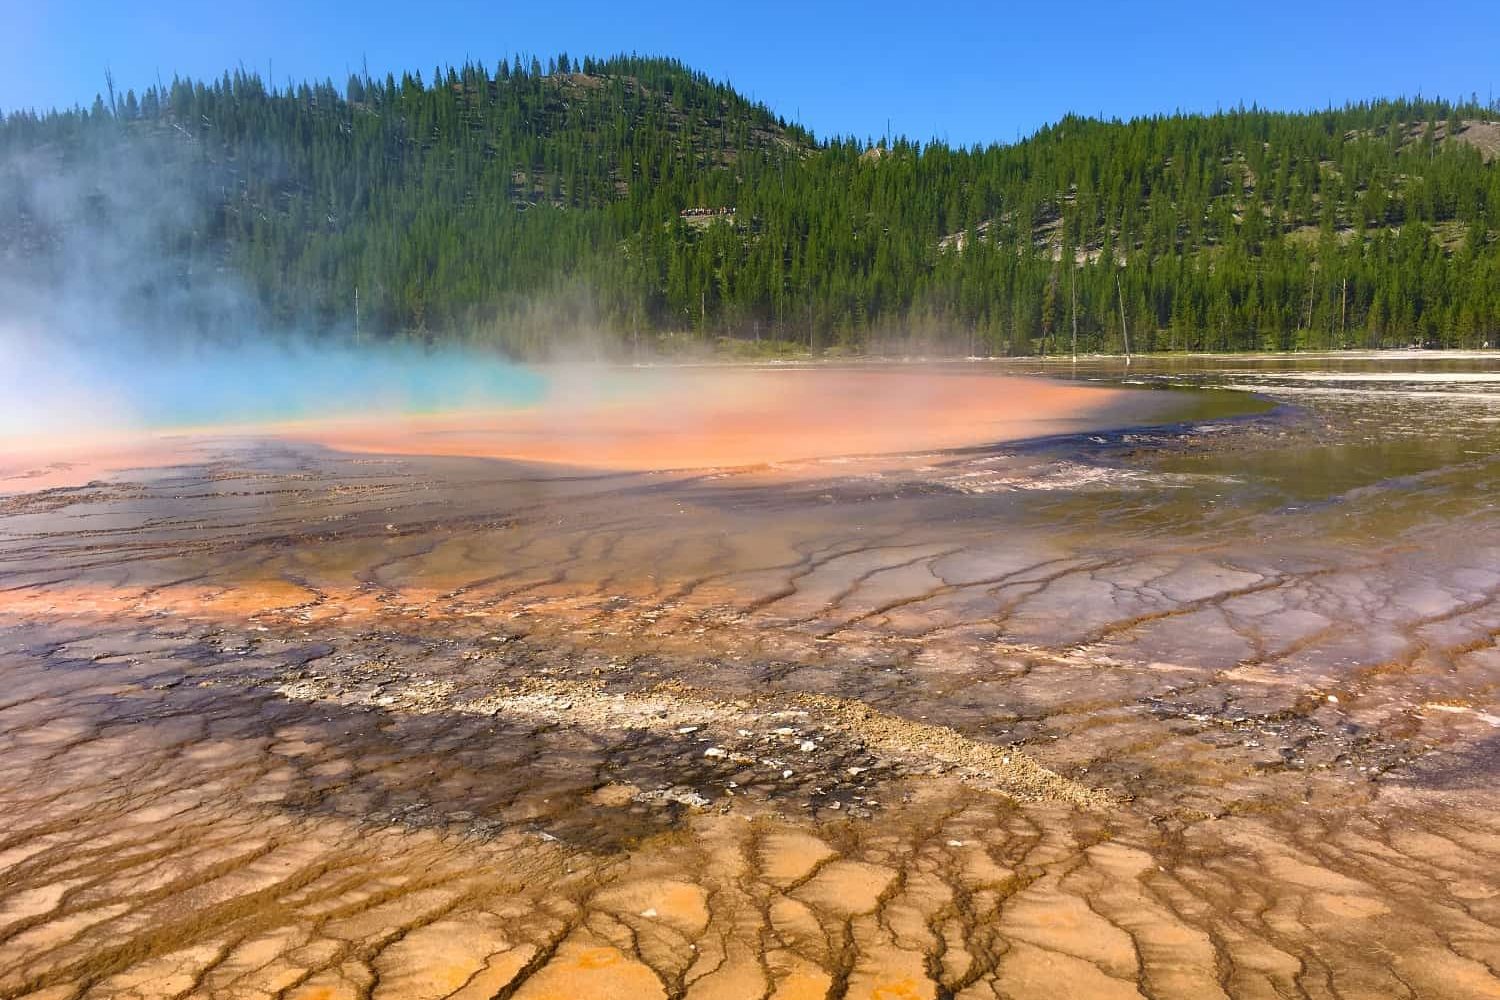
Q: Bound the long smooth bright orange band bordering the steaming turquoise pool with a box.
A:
[0,366,1164,495]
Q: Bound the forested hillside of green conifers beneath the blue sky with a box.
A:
[0,55,1500,354]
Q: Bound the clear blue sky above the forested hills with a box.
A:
[0,0,1500,144]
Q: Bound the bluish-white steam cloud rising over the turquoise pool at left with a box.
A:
[0,133,545,450]
